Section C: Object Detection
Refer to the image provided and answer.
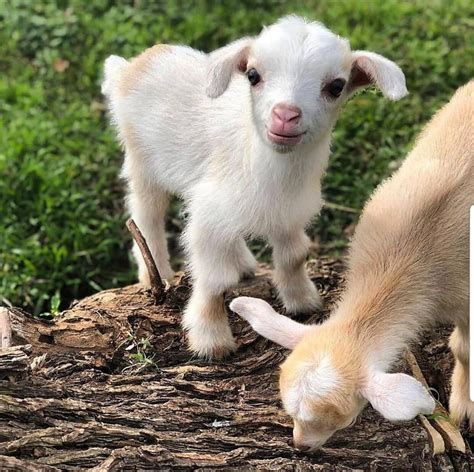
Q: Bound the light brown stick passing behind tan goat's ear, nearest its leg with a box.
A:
[405,351,466,453]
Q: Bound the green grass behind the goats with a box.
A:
[0,0,474,313]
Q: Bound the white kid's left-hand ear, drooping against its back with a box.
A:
[206,38,252,98]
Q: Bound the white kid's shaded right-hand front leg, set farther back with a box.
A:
[271,230,322,313]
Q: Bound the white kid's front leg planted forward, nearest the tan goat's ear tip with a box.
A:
[182,221,243,359]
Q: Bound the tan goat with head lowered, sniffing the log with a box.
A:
[231,81,474,450]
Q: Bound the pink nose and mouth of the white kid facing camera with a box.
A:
[268,103,304,144]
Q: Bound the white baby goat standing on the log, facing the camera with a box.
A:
[103,16,407,357]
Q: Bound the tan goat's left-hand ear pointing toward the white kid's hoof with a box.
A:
[230,297,311,349]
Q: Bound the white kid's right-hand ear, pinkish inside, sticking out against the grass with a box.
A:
[348,51,408,100]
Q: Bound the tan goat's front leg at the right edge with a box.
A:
[449,324,474,430]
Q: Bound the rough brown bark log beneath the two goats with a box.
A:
[0,260,474,471]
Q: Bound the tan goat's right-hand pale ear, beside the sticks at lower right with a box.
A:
[361,372,436,421]
